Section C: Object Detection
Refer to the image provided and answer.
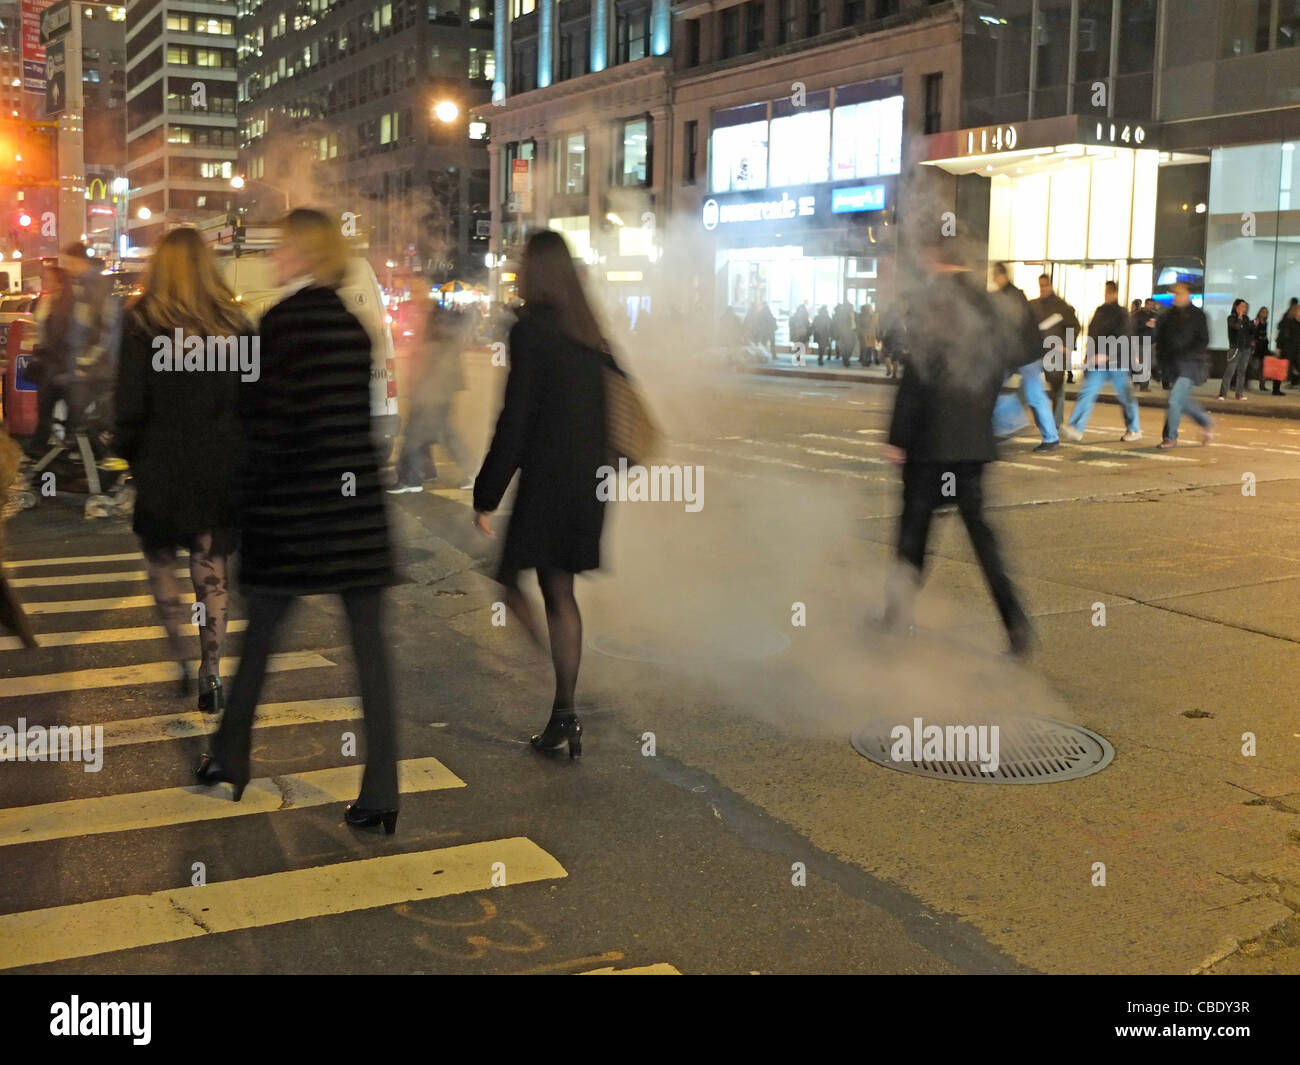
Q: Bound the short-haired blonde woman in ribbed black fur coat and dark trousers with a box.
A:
[196,209,398,832]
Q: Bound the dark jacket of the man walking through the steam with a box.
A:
[889,273,1027,463]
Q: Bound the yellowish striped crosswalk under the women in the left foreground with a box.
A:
[0,540,677,974]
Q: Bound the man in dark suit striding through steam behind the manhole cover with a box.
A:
[885,248,1032,655]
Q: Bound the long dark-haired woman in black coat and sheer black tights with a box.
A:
[475,230,611,758]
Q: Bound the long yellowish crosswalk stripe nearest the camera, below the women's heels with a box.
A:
[0,842,568,969]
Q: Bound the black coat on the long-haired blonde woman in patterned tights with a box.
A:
[114,305,245,550]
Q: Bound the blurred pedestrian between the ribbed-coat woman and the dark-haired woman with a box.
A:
[389,287,475,493]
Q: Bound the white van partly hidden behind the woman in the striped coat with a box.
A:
[217,255,398,462]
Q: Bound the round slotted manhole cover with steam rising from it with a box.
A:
[852,718,1115,784]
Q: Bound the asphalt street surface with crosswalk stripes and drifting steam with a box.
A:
[0,354,1300,974]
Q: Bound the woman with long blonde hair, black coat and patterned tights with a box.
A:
[114,229,256,714]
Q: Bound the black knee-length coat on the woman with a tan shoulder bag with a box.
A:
[475,308,608,584]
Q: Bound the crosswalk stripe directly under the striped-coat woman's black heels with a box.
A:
[0,758,465,847]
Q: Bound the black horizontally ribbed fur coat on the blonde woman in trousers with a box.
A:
[238,285,393,596]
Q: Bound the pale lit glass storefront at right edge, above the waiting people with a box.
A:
[1205,142,1300,347]
